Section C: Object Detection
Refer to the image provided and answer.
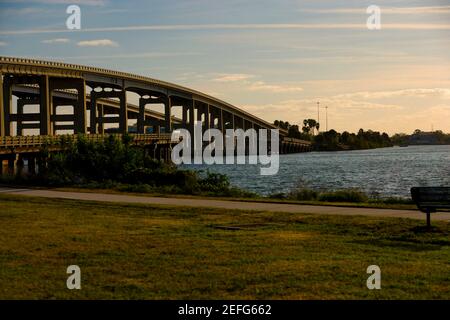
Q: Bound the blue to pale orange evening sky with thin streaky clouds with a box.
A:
[0,0,450,134]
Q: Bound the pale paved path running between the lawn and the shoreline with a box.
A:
[0,187,450,222]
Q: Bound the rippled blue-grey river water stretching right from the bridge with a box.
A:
[184,145,450,198]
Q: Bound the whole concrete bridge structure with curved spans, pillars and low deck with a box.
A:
[0,57,310,174]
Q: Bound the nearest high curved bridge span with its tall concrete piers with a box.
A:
[0,57,285,136]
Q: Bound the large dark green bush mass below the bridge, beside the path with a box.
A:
[8,135,251,197]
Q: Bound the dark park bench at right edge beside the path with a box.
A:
[411,187,450,227]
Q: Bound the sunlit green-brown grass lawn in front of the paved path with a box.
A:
[0,195,450,299]
